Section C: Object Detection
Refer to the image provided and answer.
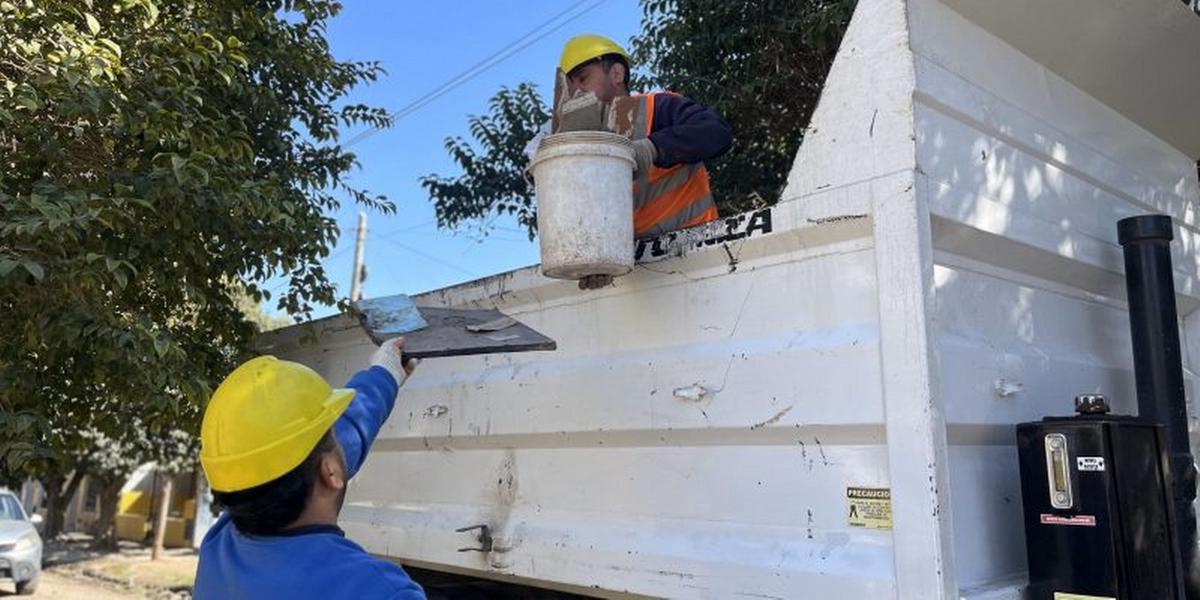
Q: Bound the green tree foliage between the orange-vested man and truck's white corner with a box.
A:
[632,0,856,214]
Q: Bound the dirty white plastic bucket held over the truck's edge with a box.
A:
[530,131,634,280]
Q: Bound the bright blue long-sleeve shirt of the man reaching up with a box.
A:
[193,366,425,600]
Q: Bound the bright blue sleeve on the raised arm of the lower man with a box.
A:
[334,366,400,479]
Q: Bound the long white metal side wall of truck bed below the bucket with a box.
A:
[265,198,902,598]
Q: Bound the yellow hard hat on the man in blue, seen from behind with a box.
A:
[200,356,354,492]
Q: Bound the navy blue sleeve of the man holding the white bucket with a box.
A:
[650,94,733,168]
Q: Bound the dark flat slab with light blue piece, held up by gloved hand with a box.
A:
[352,294,558,359]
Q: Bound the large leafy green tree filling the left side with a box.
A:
[0,0,391,480]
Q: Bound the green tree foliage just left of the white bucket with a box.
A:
[420,83,550,240]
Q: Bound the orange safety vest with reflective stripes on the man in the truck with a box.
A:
[634,92,718,238]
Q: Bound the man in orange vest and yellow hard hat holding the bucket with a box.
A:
[559,35,733,289]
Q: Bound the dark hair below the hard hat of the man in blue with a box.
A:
[212,430,337,535]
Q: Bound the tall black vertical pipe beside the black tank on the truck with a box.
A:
[1117,215,1200,600]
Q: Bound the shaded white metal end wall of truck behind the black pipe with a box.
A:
[910,0,1200,599]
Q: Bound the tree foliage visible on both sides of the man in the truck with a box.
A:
[421,0,856,238]
